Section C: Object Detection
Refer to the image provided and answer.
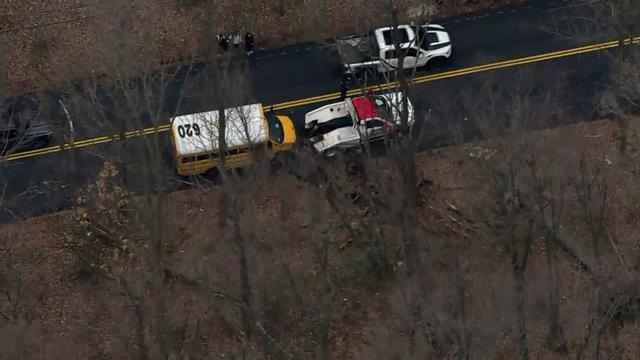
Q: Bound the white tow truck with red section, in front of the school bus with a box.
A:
[305,92,415,157]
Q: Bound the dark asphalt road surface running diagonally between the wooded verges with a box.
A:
[0,1,636,221]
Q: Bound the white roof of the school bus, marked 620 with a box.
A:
[171,104,267,156]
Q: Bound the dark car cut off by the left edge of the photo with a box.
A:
[0,97,53,154]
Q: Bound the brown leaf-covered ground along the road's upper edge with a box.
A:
[0,0,522,95]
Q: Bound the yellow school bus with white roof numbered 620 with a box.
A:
[171,104,296,176]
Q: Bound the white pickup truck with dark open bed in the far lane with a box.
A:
[336,24,452,75]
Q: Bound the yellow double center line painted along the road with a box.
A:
[5,36,640,161]
